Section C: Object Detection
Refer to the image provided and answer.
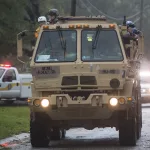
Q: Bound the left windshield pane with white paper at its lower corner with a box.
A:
[35,29,77,62]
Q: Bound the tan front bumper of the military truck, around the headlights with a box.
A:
[29,94,134,120]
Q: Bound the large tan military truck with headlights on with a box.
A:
[17,17,143,147]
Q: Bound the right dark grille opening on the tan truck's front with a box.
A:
[80,76,97,85]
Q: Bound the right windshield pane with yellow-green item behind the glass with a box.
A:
[81,29,123,61]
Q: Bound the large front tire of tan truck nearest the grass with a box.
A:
[30,121,50,147]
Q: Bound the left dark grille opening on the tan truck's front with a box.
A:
[61,76,78,85]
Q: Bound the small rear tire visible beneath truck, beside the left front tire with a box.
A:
[51,127,63,140]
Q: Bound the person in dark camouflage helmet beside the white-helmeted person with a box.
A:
[48,8,59,24]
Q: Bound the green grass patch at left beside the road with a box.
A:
[0,107,29,139]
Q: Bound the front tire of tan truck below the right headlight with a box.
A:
[119,118,137,146]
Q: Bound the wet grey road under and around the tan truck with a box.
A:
[4,106,150,150]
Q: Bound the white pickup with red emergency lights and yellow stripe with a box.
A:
[0,64,32,104]
